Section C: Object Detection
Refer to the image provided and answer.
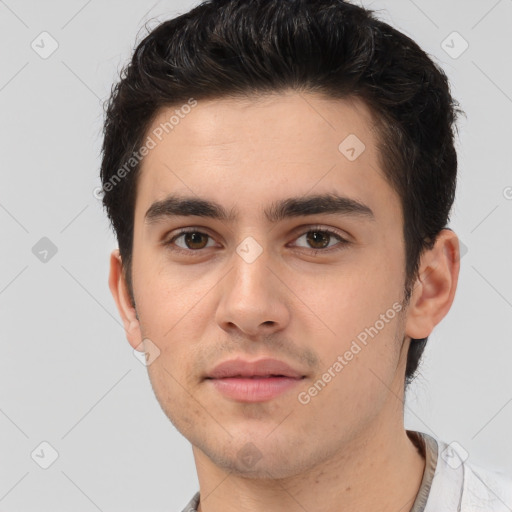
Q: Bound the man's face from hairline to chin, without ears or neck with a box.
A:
[115,93,408,477]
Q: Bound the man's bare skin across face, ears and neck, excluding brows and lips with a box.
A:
[109,92,459,512]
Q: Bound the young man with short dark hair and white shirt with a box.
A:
[101,0,512,512]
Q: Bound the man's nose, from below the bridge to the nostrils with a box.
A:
[216,245,290,338]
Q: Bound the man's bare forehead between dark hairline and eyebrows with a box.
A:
[135,93,397,226]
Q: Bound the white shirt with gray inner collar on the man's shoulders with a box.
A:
[182,430,512,512]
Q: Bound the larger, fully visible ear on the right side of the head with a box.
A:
[405,229,460,339]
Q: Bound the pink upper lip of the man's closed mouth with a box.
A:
[206,359,304,379]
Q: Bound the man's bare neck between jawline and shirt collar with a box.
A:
[193,422,425,512]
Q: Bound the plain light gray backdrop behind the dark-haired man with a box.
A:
[0,0,512,512]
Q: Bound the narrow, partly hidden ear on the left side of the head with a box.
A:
[108,249,143,352]
